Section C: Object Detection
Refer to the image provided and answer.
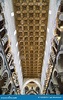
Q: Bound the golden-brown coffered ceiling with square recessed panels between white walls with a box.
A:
[13,0,49,78]
